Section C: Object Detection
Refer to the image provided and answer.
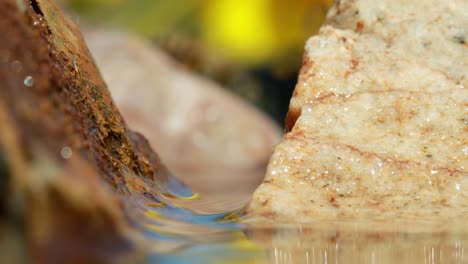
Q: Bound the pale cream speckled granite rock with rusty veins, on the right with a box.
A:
[245,0,468,222]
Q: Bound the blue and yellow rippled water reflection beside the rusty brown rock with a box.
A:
[120,174,264,263]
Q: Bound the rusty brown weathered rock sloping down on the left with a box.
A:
[0,0,171,263]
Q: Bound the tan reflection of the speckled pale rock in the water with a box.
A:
[250,228,468,264]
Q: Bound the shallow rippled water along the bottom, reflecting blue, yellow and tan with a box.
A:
[119,175,468,264]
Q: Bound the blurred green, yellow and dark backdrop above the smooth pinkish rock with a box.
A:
[61,0,332,127]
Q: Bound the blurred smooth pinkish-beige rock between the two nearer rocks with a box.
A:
[85,29,280,211]
